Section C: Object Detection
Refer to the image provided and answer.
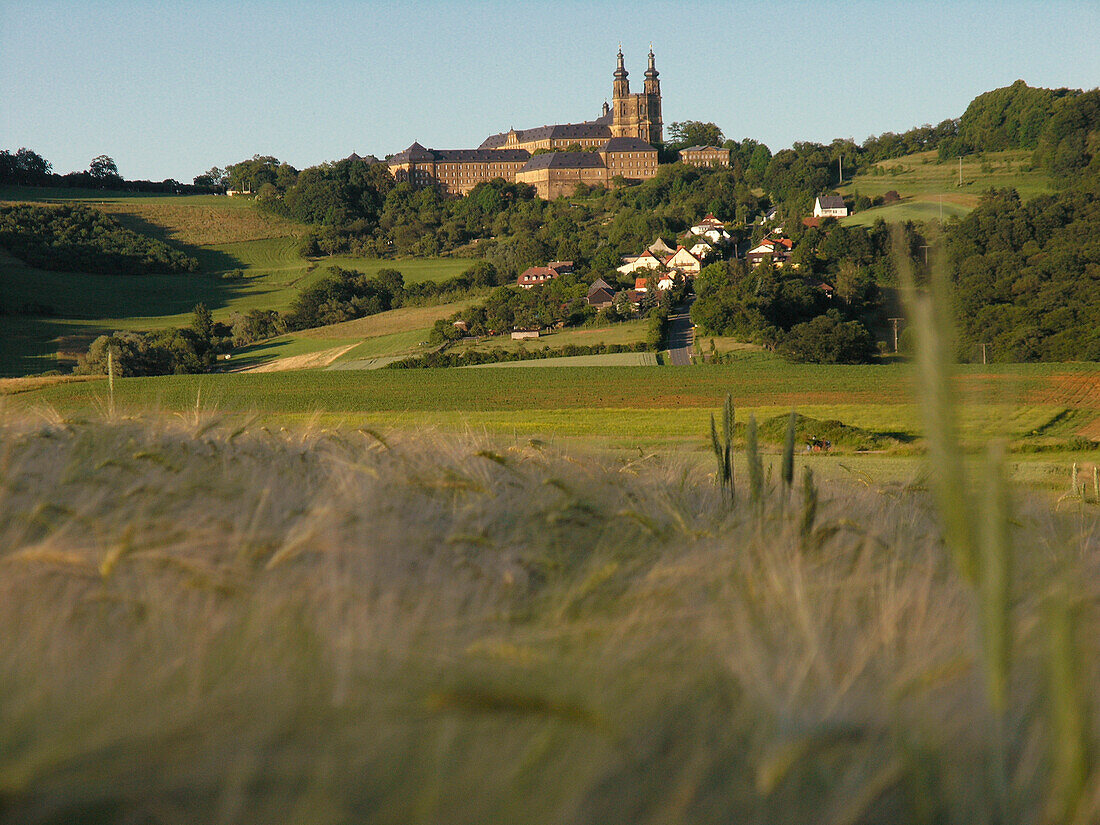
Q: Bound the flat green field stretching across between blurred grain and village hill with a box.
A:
[9,356,1100,452]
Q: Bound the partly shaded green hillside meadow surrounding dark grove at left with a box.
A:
[0,187,472,375]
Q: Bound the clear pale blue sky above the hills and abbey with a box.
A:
[0,0,1100,182]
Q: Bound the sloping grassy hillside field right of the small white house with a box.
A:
[839,150,1054,224]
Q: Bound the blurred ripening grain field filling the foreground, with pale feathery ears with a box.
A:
[0,414,1100,825]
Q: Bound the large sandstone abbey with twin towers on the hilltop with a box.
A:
[389,50,663,199]
